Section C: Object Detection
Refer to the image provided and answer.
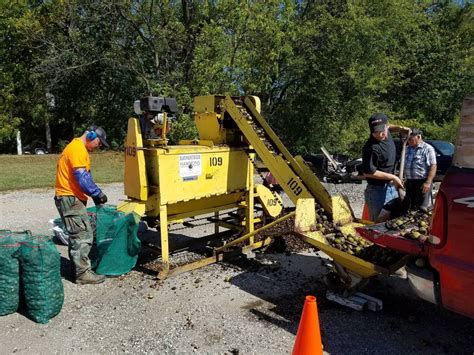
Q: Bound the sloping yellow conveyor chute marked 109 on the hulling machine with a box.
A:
[219,96,389,284]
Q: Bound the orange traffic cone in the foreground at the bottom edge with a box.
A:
[292,296,323,355]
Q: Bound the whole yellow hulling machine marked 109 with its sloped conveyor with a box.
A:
[119,95,408,287]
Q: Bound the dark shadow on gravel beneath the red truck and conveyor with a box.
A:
[230,250,474,354]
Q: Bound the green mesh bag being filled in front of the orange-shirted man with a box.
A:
[87,206,141,276]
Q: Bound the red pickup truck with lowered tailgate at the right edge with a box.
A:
[358,97,474,318]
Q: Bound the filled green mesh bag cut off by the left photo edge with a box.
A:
[0,230,29,316]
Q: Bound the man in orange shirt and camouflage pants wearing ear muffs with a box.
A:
[54,126,109,284]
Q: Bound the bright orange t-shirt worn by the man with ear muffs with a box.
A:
[56,138,91,201]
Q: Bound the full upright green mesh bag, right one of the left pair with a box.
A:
[16,236,64,323]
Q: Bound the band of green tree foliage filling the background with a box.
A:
[0,0,474,155]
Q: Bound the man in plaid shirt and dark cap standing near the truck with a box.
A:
[405,128,436,209]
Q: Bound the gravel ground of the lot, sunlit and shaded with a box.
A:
[0,184,474,354]
